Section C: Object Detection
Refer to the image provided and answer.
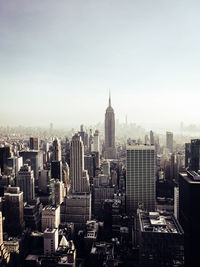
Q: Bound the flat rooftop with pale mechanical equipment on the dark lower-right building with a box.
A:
[139,211,183,234]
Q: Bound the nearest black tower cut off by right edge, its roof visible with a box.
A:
[179,171,200,267]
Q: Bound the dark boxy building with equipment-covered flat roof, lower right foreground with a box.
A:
[138,211,184,267]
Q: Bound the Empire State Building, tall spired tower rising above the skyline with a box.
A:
[104,95,116,159]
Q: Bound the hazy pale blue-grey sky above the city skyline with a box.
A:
[0,0,200,130]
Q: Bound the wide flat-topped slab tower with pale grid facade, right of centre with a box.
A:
[126,145,156,213]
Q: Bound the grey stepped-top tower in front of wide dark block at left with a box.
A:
[16,164,35,202]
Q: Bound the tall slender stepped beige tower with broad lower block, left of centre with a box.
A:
[61,134,91,229]
